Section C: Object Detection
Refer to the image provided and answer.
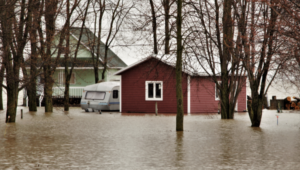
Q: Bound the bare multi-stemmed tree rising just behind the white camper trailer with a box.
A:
[86,0,133,83]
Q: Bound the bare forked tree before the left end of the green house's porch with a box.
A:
[38,0,80,112]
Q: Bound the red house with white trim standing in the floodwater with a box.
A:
[115,57,246,113]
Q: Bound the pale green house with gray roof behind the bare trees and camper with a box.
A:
[24,27,127,105]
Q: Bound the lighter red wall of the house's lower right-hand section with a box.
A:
[190,77,246,113]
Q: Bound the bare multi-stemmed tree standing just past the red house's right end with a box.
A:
[235,0,286,127]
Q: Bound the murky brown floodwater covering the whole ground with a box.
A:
[0,108,300,170]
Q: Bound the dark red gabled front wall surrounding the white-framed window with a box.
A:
[121,58,187,113]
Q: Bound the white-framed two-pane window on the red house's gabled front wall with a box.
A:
[145,81,163,101]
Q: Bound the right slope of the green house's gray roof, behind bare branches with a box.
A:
[70,27,127,67]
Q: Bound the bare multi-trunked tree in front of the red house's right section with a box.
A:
[184,0,246,119]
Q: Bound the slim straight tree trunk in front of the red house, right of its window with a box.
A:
[176,0,184,131]
